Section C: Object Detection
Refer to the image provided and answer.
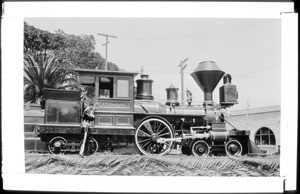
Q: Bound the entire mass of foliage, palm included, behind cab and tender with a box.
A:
[24,22,120,102]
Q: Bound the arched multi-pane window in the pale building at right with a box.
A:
[255,127,276,145]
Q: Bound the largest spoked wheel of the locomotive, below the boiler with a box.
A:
[134,118,173,155]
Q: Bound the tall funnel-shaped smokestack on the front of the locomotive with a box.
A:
[191,61,225,102]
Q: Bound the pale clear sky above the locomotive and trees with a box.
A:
[25,17,281,110]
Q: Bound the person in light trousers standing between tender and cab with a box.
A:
[79,103,97,157]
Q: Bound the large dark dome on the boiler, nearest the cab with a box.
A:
[135,74,154,100]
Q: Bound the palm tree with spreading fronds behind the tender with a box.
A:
[24,53,78,105]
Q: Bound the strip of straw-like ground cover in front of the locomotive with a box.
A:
[25,153,280,177]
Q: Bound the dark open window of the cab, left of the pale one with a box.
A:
[99,77,114,98]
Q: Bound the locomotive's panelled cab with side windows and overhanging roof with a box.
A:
[75,69,137,135]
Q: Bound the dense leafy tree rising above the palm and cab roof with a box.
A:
[24,22,119,71]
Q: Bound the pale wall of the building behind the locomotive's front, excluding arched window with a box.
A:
[227,106,280,154]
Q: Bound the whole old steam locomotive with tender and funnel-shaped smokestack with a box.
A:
[38,61,262,157]
